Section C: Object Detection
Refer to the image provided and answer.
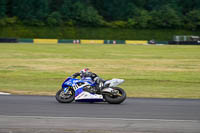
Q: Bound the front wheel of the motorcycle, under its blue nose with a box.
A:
[56,89,75,103]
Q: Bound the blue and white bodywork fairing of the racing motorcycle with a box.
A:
[62,77,104,102]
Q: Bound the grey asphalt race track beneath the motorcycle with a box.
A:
[0,95,200,133]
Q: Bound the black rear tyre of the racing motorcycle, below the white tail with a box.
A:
[104,87,126,104]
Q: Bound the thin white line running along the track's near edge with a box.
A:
[0,115,200,123]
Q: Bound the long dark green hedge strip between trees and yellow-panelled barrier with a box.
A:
[0,25,200,41]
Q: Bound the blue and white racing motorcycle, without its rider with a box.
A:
[56,77,126,104]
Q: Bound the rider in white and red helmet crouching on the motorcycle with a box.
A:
[72,68,105,92]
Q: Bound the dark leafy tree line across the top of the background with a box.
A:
[0,0,200,30]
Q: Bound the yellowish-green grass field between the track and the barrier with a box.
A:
[0,44,200,98]
